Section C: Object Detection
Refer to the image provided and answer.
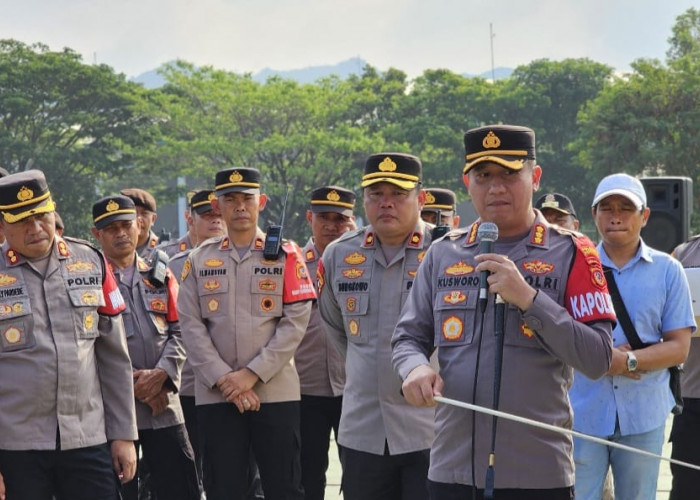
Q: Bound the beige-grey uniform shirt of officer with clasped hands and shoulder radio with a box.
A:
[178,229,316,405]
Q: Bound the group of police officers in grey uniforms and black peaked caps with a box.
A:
[0,125,697,500]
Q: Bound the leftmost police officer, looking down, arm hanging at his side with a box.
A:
[0,170,137,500]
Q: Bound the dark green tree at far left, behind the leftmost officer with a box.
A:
[0,40,150,236]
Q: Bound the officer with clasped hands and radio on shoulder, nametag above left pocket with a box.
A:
[178,167,316,500]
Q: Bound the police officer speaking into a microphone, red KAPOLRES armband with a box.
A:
[392,125,615,500]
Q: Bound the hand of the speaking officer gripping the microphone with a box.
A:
[474,253,537,311]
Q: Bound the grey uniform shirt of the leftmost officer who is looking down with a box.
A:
[0,236,138,450]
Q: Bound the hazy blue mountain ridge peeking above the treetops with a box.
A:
[131,57,513,89]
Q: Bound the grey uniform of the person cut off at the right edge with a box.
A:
[669,236,700,500]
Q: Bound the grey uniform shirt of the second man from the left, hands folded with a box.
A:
[114,256,185,429]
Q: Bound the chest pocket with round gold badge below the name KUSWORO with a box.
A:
[433,289,479,347]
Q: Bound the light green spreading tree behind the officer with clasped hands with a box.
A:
[142,62,382,240]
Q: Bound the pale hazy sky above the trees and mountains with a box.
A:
[0,0,697,77]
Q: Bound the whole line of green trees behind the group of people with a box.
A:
[0,9,700,240]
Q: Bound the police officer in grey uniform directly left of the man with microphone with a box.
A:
[319,153,434,500]
